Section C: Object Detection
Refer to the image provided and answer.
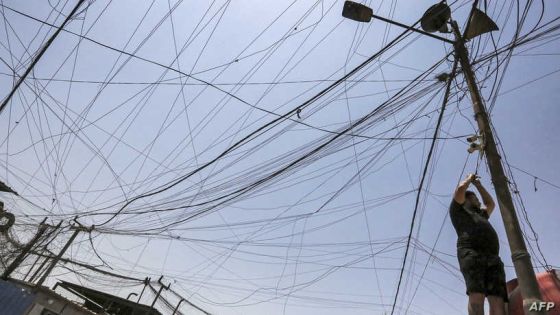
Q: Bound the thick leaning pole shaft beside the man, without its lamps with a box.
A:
[451,21,546,315]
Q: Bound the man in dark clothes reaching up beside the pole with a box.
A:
[449,174,507,315]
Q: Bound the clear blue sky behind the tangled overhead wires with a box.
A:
[0,0,560,315]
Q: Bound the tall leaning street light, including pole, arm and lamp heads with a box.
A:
[342,1,546,315]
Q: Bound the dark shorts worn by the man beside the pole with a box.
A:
[457,248,508,302]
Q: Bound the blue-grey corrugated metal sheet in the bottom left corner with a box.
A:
[0,280,35,315]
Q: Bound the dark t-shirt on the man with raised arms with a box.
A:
[449,200,500,255]
